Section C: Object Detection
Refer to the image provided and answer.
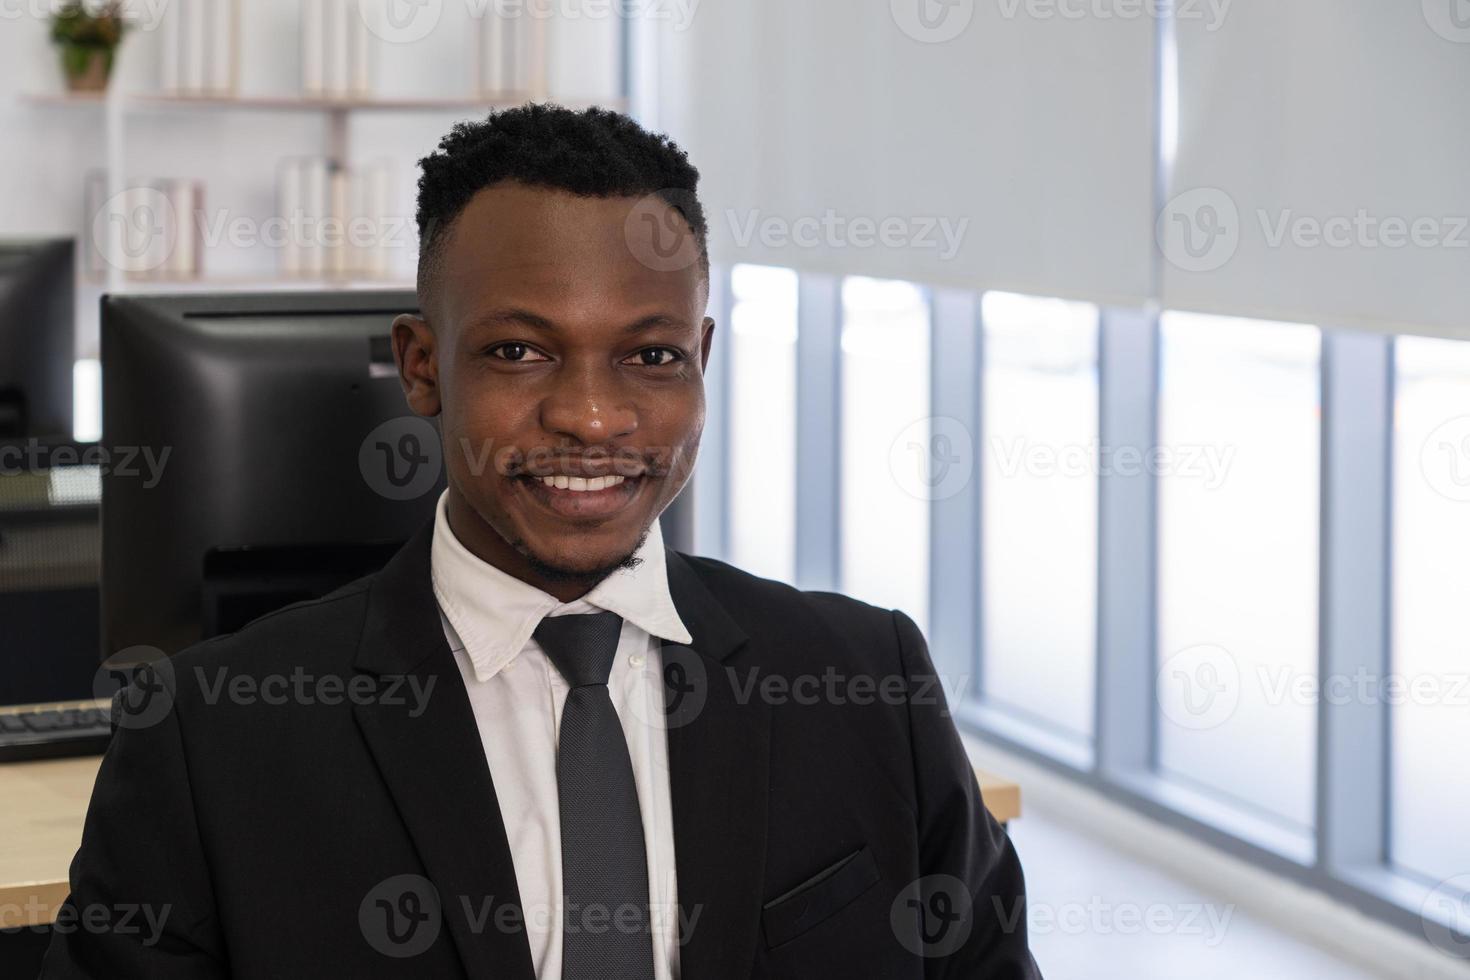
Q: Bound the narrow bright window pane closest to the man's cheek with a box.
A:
[728,266,797,582]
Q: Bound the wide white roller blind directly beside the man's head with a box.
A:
[657,0,1157,303]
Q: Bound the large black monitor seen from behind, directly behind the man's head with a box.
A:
[101,291,444,657]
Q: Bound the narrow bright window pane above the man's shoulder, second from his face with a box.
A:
[839,278,931,630]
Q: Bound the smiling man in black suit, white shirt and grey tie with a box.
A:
[44,106,1039,980]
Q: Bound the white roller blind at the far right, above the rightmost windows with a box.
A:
[1158,0,1470,332]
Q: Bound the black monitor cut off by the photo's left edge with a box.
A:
[0,238,76,439]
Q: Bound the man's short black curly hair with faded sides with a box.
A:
[417,103,709,303]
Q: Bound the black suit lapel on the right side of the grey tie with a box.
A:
[663,550,770,979]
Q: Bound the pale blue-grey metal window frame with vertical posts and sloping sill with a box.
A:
[703,273,1461,942]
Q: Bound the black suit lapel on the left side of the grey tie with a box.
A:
[354,523,535,980]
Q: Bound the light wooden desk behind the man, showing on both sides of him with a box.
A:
[0,755,1020,929]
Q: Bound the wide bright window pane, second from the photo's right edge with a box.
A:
[1150,313,1322,832]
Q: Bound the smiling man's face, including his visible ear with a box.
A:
[394,182,713,586]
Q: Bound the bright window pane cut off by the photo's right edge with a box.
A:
[1382,336,1470,880]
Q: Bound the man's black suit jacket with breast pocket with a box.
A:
[43,527,1039,980]
